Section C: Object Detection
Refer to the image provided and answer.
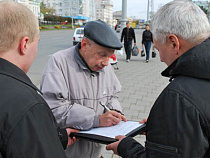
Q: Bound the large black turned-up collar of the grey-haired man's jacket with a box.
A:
[161,38,210,80]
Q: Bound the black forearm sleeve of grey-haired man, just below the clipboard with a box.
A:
[117,137,146,158]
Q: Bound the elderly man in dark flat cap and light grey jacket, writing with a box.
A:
[41,20,126,158]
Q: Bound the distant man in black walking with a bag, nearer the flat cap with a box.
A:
[121,22,136,62]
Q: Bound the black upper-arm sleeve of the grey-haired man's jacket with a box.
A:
[146,88,209,158]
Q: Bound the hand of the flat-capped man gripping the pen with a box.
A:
[99,111,127,127]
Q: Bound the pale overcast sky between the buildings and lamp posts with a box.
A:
[112,0,172,20]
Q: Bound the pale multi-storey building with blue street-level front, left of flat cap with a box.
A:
[43,0,96,20]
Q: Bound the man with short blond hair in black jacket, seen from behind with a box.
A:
[0,2,77,158]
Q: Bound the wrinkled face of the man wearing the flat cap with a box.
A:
[81,41,114,71]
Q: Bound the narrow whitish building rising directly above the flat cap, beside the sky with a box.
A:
[96,0,114,26]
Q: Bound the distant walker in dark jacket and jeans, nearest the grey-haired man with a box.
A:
[141,24,153,63]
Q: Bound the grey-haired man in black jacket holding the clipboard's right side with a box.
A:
[107,1,210,158]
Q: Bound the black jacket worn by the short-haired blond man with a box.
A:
[0,58,67,158]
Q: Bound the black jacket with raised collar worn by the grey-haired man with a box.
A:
[118,39,210,158]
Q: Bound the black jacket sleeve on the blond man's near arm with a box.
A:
[6,104,66,158]
